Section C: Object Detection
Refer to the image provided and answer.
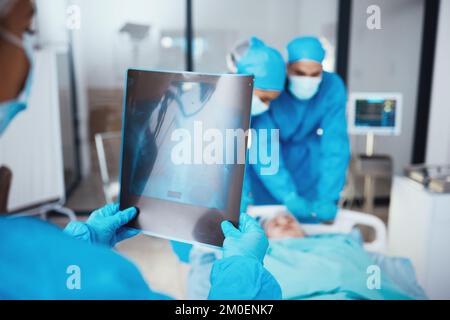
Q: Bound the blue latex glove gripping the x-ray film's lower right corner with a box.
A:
[221,213,269,263]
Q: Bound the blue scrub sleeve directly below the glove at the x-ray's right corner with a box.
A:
[208,256,281,300]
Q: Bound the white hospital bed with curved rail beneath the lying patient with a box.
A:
[188,205,426,299]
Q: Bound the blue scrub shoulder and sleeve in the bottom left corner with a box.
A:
[0,218,170,300]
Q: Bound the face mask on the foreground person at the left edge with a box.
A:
[0,28,33,136]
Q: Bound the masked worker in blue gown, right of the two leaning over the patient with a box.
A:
[246,37,350,223]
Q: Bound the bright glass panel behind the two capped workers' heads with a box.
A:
[193,0,338,72]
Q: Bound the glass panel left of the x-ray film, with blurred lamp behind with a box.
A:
[63,0,186,211]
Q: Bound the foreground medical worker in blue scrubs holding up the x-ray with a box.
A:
[0,0,281,299]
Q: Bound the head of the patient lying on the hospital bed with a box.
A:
[263,213,305,239]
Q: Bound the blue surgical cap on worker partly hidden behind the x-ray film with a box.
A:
[236,37,286,91]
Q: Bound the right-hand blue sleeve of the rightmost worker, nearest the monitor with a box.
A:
[316,78,350,208]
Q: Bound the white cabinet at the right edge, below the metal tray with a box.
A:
[388,177,450,299]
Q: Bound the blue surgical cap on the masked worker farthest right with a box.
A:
[287,37,325,63]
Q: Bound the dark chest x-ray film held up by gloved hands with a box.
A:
[120,70,253,246]
